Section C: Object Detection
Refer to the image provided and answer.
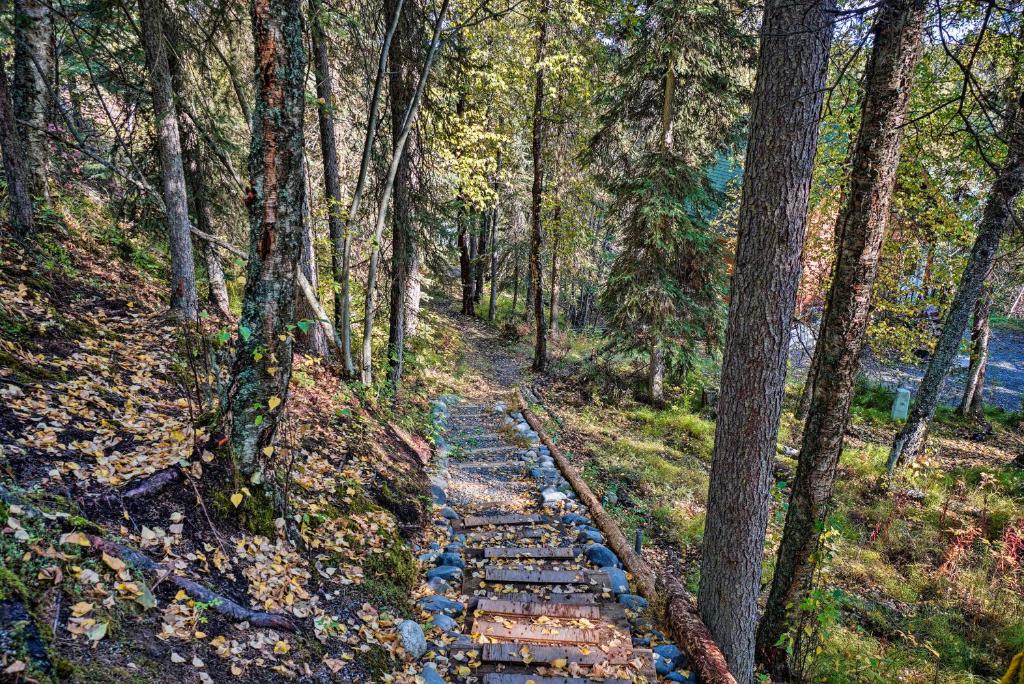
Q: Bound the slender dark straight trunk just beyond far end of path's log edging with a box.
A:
[527,0,551,373]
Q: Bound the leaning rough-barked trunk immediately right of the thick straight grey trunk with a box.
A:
[757,0,927,662]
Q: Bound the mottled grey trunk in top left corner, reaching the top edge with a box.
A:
[12,0,56,202]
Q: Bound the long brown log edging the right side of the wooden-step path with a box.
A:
[516,389,736,684]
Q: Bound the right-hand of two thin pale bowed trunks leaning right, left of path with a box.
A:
[360,0,451,387]
